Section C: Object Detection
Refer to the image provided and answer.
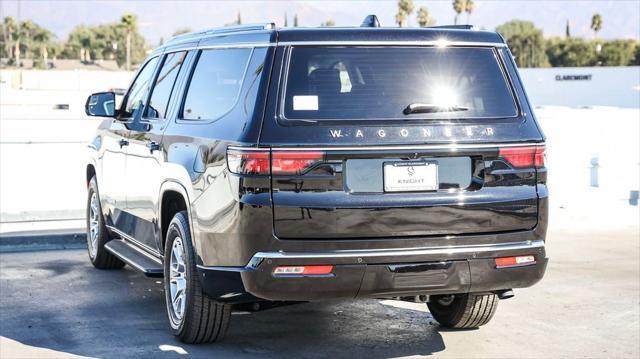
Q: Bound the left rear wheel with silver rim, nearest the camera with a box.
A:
[164,211,231,344]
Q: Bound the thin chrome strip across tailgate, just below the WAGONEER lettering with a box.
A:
[228,142,545,152]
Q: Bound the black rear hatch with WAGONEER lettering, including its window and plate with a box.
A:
[261,46,544,239]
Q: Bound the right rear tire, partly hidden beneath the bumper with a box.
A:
[427,294,498,329]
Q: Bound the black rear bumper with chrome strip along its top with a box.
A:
[198,240,547,302]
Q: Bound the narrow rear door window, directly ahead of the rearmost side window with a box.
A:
[146,51,187,118]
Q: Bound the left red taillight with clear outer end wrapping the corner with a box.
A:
[227,148,324,175]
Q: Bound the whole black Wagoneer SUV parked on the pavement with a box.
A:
[86,19,548,343]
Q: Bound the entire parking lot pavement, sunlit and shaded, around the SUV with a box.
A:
[0,226,640,359]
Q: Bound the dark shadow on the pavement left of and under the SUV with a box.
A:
[0,250,445,359]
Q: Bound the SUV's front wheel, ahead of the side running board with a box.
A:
[87,176,124,269]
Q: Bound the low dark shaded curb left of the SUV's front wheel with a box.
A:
[0,229,87,253]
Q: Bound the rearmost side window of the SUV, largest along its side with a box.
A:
[183,49,251,120]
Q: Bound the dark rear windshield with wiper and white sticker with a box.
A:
[283,47,517,120]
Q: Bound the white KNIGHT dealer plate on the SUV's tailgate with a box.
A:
[383,161,439,192]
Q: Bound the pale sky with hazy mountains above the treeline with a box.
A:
[0,0,640,44]
